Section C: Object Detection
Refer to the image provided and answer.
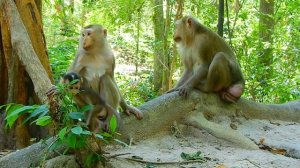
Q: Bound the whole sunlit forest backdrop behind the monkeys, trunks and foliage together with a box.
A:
[42,0,300,106]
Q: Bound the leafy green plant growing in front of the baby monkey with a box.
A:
[0,81,126,167]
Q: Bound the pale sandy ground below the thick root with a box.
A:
[102,117,300,168]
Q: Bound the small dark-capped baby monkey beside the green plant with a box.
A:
[62,72,120,132]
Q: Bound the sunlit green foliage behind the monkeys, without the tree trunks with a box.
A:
[43,0,300,105]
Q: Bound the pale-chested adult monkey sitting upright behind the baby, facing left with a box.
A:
[70,25,143,119]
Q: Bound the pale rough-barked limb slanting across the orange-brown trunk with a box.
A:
[3,0,51,102]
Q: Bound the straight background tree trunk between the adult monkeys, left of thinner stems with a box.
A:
[153,0,165,91]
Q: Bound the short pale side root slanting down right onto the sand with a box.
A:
[187,111,259,150]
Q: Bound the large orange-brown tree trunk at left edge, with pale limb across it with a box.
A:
[0,0,53,148]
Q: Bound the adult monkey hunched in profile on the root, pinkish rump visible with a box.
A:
[169,16,245,103]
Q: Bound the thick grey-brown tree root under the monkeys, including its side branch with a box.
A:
[0,91,300,167]
